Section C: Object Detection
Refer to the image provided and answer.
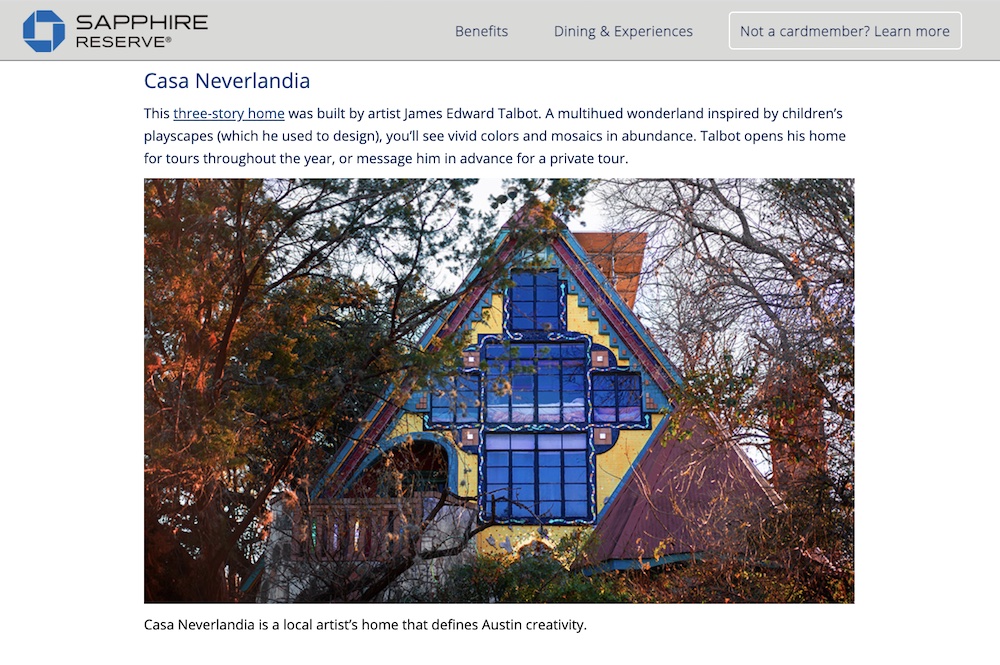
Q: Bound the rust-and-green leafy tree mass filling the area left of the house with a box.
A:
[144,179,500,600]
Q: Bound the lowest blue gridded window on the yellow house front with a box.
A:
[482,433,590,522]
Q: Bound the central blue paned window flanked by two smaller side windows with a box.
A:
[486,343,587,424]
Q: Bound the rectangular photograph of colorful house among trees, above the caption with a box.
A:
[143,178,854,604]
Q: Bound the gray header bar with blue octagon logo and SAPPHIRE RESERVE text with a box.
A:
[0,0,1000,61]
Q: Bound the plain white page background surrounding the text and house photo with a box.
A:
[0,62,1000,663]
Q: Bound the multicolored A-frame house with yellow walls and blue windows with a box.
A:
[256,207,776,600]
